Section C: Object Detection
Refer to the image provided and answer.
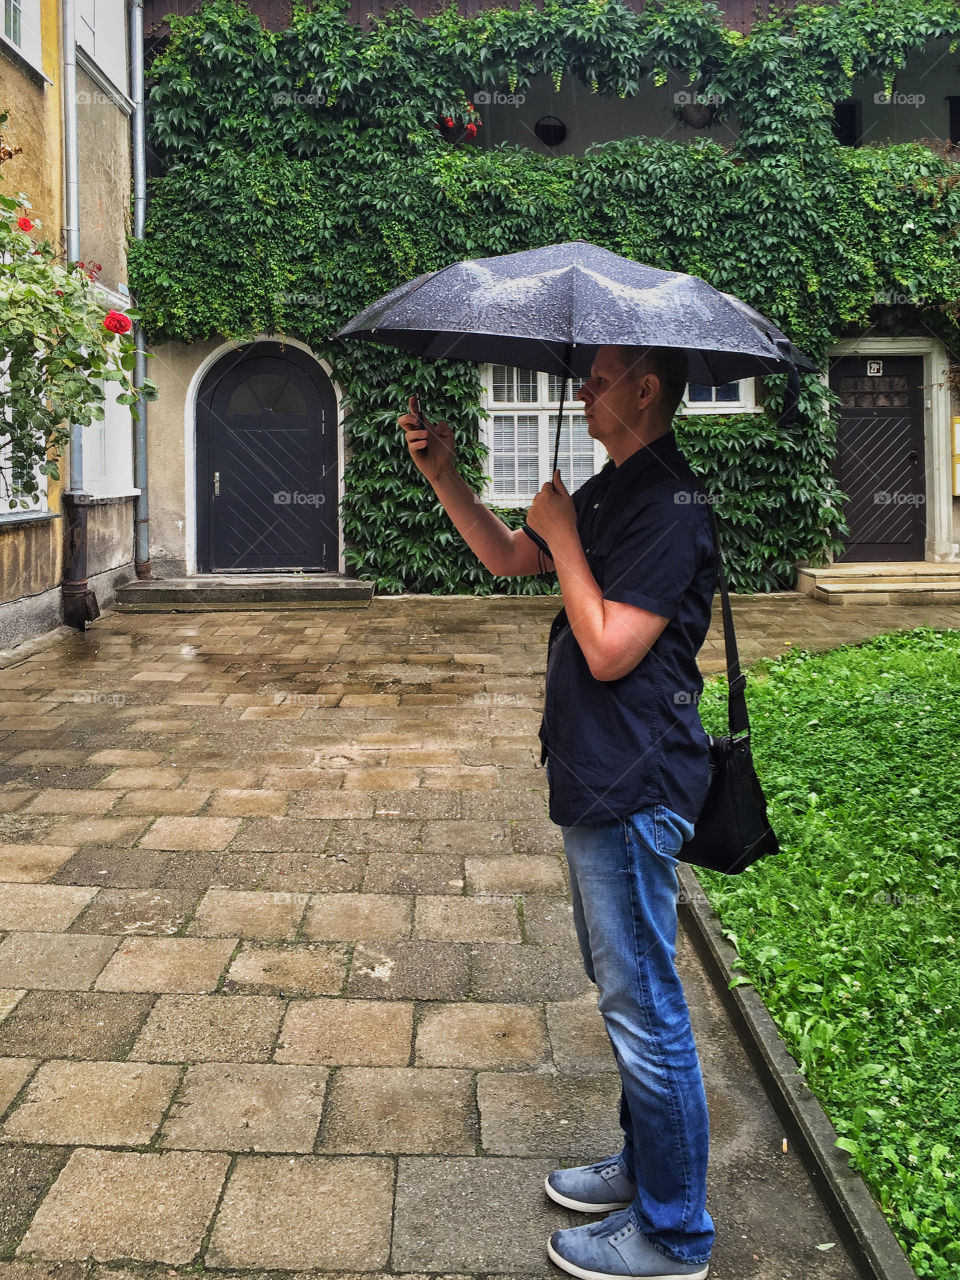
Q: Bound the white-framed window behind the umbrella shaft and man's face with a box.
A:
[480,365,607,507]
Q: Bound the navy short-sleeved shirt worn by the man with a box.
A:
[540,431,716,827]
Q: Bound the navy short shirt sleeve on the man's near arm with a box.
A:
[603,490,703,618]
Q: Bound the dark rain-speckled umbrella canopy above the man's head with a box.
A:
[334,241,813,385]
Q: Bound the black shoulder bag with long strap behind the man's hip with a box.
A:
[677,512,780,876]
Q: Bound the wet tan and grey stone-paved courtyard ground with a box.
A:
[0,595,960,1280]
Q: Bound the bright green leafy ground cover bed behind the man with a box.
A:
[700,627,960,1280]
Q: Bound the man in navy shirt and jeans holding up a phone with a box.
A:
[399,347,714,1280]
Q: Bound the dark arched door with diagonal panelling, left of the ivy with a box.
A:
[195,340,340,572]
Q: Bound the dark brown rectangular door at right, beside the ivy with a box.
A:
[829,356,927,563]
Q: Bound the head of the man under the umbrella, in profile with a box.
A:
[581,346,687,460]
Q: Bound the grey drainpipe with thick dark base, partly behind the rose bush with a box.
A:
[60,0,100,631]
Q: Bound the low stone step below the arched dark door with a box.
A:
[116,573,374,613]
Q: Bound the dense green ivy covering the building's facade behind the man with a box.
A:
[131,0,960,591]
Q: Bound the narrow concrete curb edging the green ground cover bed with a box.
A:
[677,864,916,1280]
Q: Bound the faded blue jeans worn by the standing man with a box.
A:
[561,805,714,1262]
